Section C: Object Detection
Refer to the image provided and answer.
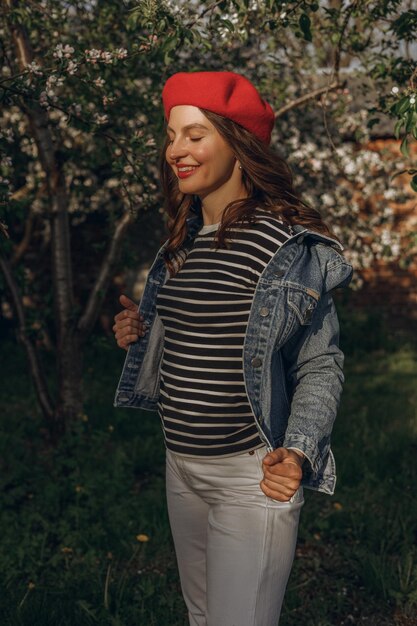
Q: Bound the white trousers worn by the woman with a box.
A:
[166,447,304,626]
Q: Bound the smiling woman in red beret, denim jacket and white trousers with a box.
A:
[113,72,352,626]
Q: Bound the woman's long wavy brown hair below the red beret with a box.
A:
[160,109,339,275]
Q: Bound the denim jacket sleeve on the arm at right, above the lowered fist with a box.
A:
[282,292,344,478]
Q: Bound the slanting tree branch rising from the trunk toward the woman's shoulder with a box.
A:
[78,212,133,340]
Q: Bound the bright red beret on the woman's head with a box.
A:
[162,72,275,144]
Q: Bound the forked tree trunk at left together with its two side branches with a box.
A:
[3,0,133,441]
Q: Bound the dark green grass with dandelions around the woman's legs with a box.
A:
[0,330,417,626]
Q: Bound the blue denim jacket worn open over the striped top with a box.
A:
[114,215,353,494]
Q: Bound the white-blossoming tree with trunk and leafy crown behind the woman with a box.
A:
[0,0,417,434]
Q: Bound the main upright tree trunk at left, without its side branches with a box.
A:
[4,0,82,438]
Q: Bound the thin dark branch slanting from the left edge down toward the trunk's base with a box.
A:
[0,256,54,422]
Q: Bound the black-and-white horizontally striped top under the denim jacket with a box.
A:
[157,210,293,458]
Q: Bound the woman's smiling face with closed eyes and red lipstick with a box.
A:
[166,105,241,198]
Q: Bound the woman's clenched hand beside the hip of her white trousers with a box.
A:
[260,448,304,502]
